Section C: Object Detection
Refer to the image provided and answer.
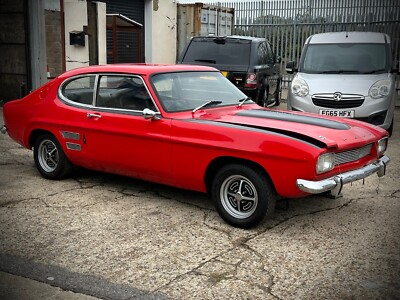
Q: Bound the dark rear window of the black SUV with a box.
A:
[183,38,251,66]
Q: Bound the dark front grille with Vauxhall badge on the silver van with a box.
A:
[311,94,365,108]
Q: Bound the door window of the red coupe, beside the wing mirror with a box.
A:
[96,75,157,111]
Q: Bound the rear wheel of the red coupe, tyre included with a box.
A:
[33,134,72,179]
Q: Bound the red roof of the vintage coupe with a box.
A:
[60,63,218,77]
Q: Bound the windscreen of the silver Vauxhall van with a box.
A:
[300,44,388,74]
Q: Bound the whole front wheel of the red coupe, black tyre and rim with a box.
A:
[211,164,276,228]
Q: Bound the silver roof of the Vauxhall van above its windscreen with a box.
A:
[306,31,390,44]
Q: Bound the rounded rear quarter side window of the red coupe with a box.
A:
[61,75,96,105]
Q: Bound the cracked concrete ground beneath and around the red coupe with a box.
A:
[0,104,400,300]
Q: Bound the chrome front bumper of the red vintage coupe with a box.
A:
[296,155,390,197]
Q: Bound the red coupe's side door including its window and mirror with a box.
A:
[86,74,171,184]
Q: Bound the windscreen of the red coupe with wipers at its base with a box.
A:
[150,72,247,112]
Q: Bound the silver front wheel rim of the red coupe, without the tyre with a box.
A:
[220,175,258,219]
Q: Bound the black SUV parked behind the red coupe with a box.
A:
[178,35,281,107]
